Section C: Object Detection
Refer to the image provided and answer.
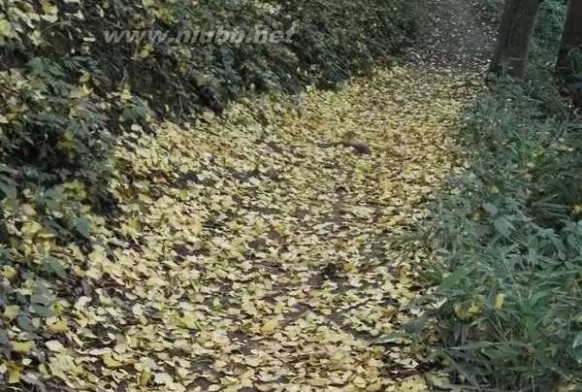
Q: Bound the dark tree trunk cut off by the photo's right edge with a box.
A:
[556,0,582,78]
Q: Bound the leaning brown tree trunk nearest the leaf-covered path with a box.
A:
[489,0,544,78]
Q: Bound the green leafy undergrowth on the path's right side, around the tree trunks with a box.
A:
[427,1,582,391]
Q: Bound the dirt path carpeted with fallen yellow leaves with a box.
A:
[32,0,496,392]
